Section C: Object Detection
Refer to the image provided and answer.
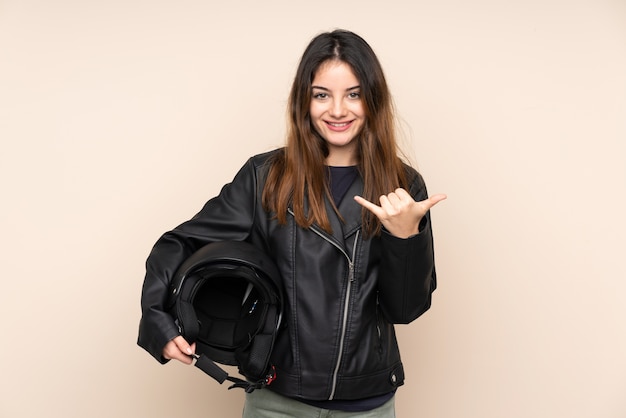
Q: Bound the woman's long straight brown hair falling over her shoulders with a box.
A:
[263,30,407,236]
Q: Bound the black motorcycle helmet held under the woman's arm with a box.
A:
[169,241,283,392]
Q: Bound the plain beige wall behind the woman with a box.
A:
[0,0,626,418]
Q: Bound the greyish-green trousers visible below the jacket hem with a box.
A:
[242,389,396,418]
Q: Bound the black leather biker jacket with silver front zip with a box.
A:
[138,151,436,400]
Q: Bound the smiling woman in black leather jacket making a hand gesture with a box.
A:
[138,30,445,418]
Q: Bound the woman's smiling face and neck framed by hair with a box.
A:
[310,60,365,166]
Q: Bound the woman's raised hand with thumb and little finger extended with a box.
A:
[354,188,447,238]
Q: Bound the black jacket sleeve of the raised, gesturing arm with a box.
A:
[378,173,437,324]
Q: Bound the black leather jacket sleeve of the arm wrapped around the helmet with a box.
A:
[137,159,258,363]
